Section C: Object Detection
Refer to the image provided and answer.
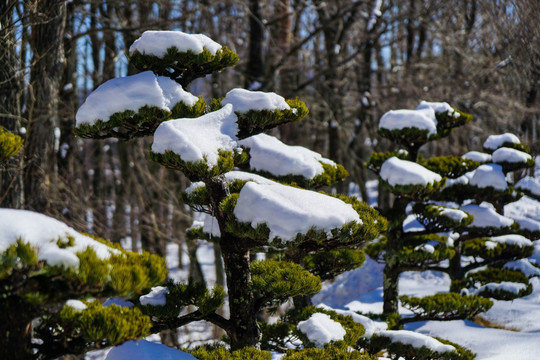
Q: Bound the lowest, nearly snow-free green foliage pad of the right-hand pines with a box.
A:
[399,293,493,322]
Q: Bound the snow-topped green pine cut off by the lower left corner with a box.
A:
[0,209,167,359]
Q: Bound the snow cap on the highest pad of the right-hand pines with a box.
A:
[379,107,437,135]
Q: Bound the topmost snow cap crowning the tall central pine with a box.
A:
[129,30,221,57]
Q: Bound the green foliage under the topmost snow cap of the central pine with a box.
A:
[129,46,239,87]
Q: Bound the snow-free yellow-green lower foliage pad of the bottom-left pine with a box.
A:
[56,301,152,346]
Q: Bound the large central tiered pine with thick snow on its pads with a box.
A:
[76,31,386,349]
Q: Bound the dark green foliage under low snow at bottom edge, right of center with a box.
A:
[358,333,475,360]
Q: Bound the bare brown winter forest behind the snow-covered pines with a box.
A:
[0,0,540,285]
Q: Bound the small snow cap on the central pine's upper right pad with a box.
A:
[221,88,291,113]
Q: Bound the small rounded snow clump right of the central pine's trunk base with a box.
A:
[297,313,345,348]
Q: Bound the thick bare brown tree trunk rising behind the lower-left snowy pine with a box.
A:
[23,0,66,212]
